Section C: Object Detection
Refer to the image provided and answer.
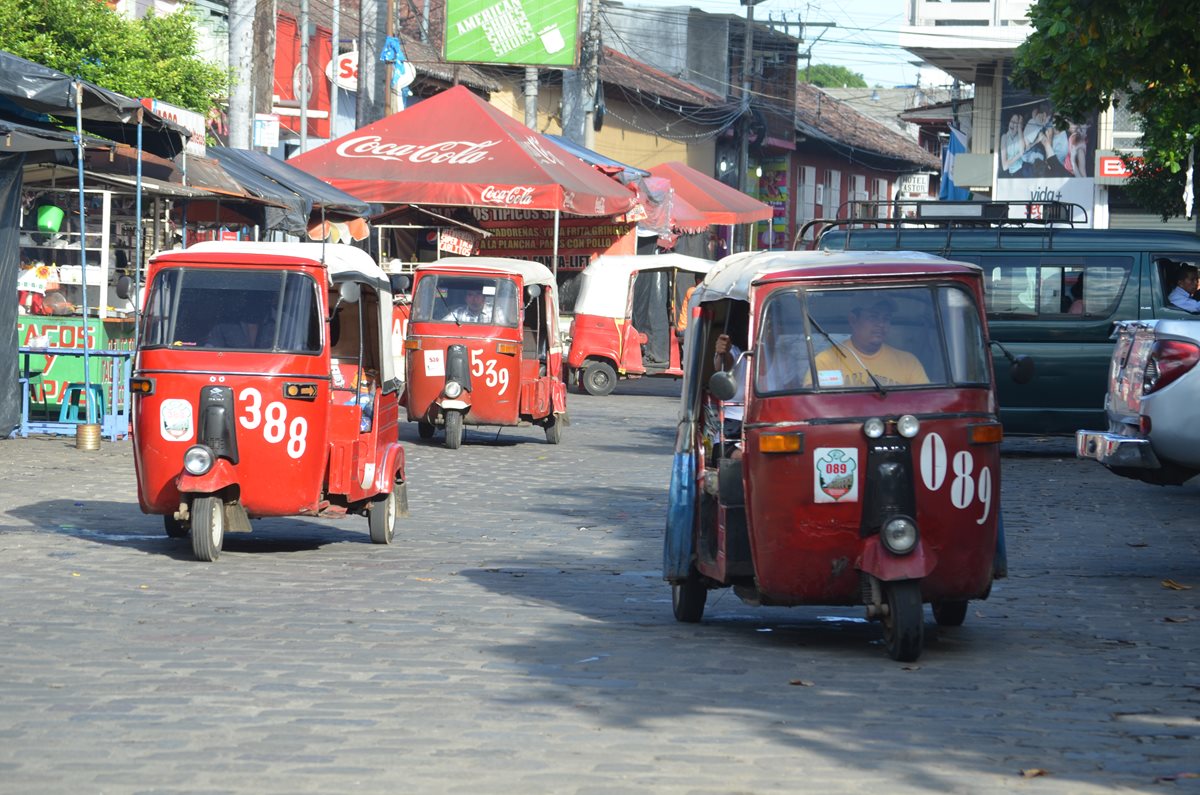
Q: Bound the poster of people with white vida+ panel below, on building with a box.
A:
[995,80,1098,226]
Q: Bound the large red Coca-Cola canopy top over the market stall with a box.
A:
[287,85,636,216]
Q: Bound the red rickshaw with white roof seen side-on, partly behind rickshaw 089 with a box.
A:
[566,253,716,395]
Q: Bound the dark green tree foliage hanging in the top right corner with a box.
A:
[1012,0,1200,220]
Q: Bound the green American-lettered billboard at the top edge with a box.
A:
[444,0,580,68]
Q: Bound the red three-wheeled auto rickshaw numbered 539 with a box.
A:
[404,257,566,449]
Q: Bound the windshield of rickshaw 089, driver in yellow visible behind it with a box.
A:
[755,286,990,394]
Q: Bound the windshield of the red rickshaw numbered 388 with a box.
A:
[142,268,322,353]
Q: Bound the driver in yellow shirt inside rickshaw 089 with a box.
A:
[816,298,929,388]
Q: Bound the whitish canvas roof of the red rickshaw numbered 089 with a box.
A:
[696,251,980,303]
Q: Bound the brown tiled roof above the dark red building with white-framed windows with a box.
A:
[796,83,941,169]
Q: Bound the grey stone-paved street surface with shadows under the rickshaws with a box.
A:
[0,381,1200,795]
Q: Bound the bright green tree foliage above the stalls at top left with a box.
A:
[0,0,229,114]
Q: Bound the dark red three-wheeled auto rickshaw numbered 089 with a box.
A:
[664,251,1032,660]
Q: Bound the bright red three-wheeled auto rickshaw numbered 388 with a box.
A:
[131,243,407,561]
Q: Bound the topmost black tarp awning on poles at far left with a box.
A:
[0,52,190,157]
